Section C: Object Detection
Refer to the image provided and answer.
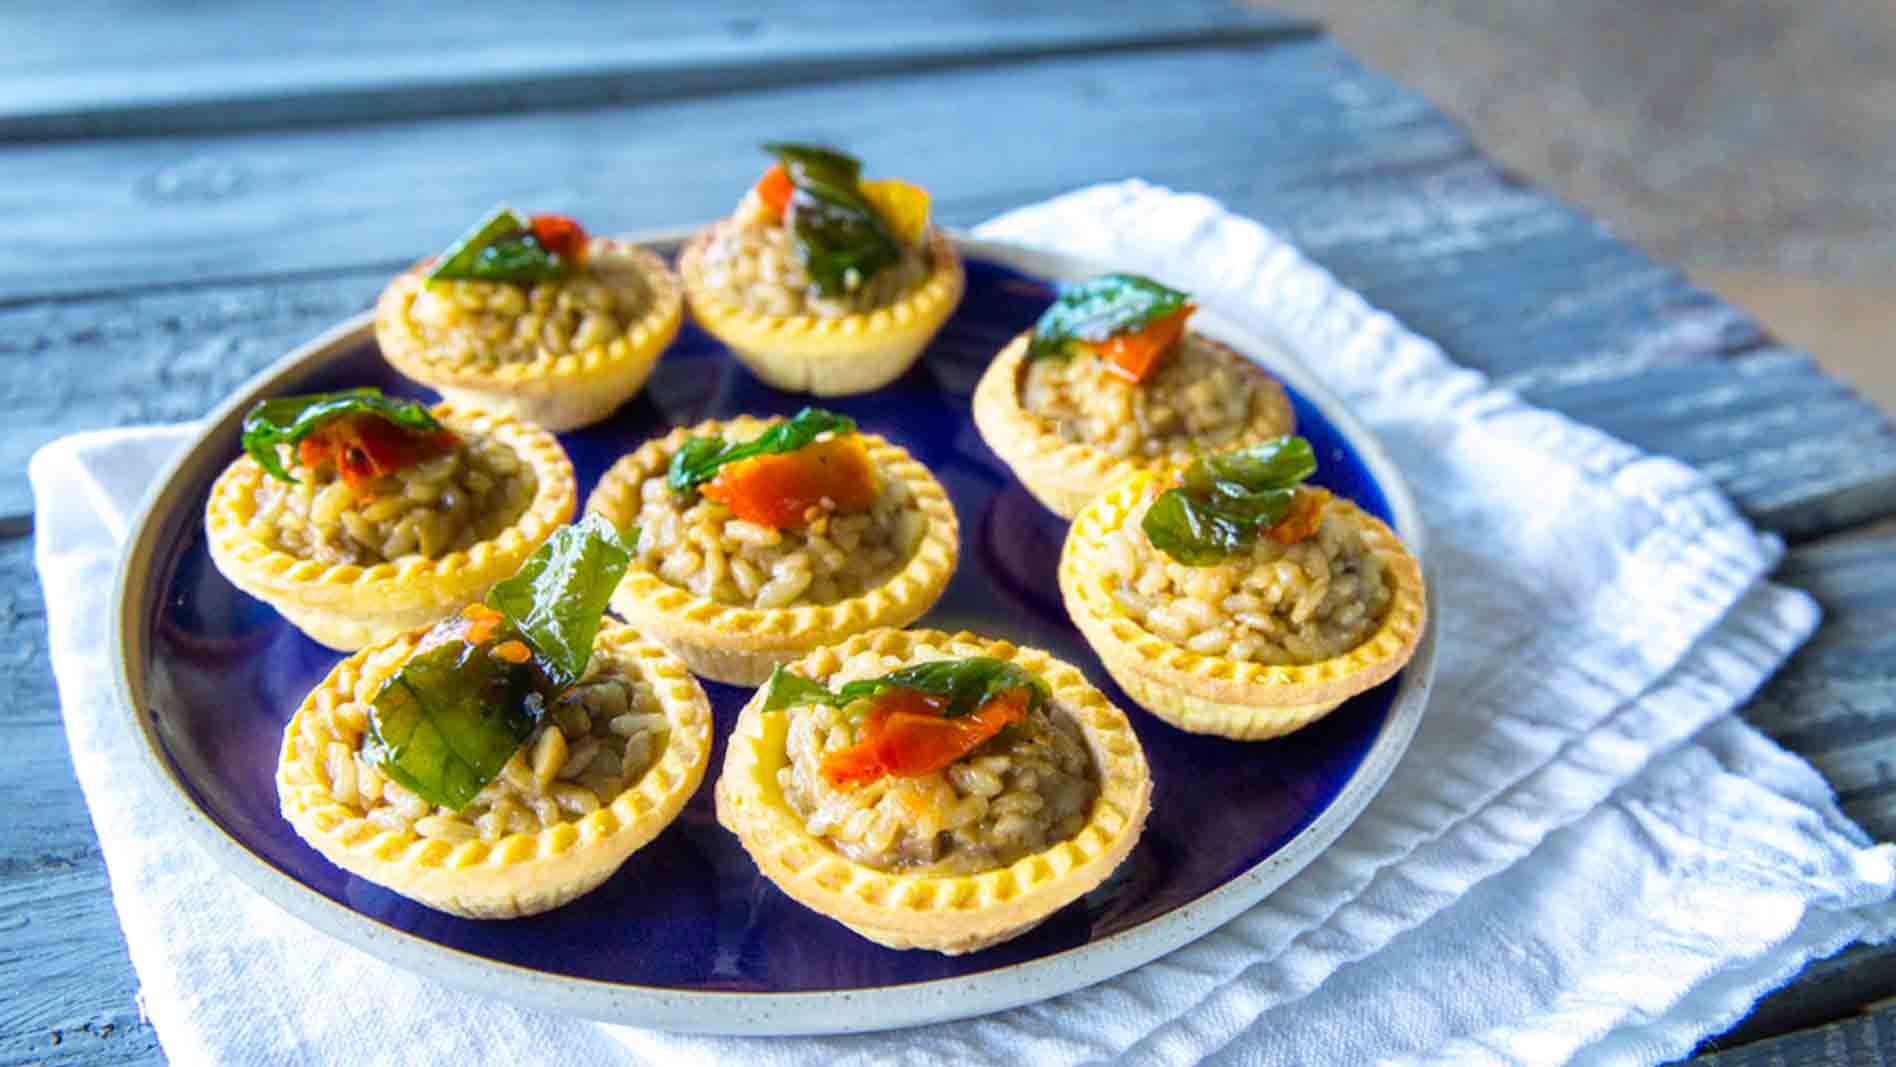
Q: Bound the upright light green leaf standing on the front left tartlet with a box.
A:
[487,512,631,688]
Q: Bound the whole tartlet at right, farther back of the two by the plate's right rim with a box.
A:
[975,275,1295,519]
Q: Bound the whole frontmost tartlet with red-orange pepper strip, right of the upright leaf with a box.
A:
[717,629,1151,955]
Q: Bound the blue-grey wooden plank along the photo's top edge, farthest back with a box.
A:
[0,0,1314,138]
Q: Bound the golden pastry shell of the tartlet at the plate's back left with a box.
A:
[375,237,684,432]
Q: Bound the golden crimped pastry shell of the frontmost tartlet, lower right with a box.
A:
[715,629,1153,955]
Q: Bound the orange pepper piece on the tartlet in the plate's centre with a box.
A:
[700,434,882,531]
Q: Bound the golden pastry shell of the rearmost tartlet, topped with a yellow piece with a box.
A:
[679,226,967,396]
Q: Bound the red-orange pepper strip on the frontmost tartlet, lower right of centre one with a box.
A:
[821,688,1028,788]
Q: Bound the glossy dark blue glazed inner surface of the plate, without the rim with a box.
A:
[146,262,1397,991]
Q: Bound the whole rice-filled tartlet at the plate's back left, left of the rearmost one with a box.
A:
[375,207,684,430]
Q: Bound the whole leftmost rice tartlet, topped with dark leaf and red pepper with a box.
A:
[205,389,578,652]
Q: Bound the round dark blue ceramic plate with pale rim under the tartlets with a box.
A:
[116,235,1433,1033]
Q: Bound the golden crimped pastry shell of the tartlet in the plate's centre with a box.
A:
[586,419,961,686]
